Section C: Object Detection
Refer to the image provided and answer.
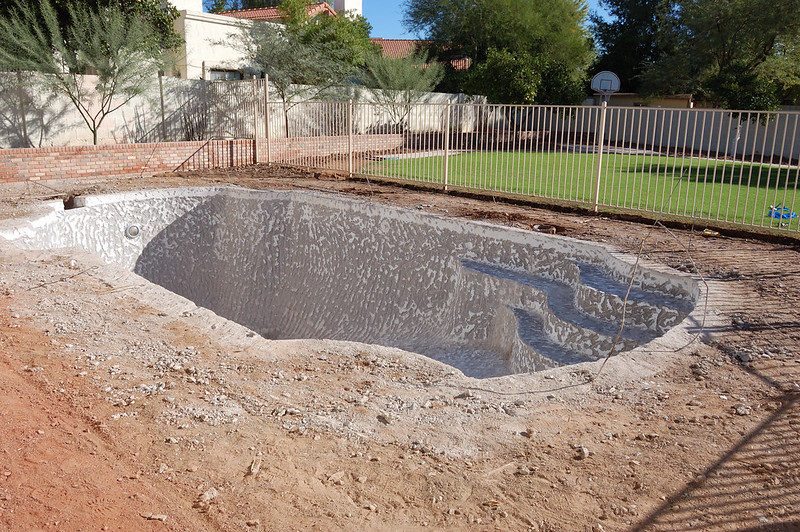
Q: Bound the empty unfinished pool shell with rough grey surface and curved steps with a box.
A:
[3,188,699,378]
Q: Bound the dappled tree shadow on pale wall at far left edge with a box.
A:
[0,72,69,148]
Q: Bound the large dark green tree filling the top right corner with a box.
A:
[643,0,800,110]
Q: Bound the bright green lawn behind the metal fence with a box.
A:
[361,151,800,229]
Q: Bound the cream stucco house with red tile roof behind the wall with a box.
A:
[170,0,362,80]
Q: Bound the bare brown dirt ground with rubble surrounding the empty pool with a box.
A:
[0,167,800,531]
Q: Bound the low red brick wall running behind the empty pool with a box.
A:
[0,135,403,184]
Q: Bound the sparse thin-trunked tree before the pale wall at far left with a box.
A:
[0,0,163,144]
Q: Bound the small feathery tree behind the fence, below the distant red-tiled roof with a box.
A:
[361,51,444,128]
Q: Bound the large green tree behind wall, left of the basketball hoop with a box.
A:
[404,0,593,103]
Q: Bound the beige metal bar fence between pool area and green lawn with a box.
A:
[170,80,800,233]
